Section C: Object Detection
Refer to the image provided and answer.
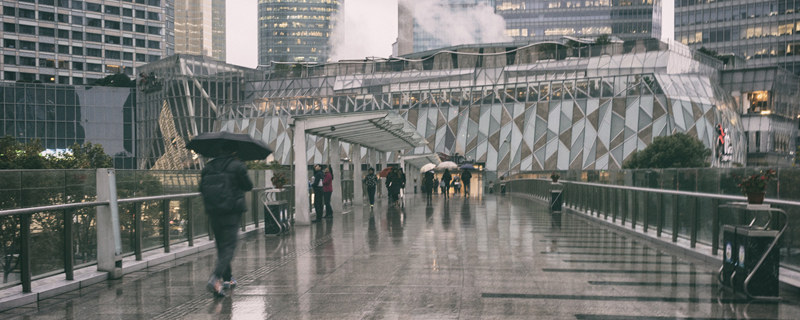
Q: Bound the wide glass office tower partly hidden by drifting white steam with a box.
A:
[398,0,662,55]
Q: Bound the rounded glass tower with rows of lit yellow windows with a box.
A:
[258,0,344,65]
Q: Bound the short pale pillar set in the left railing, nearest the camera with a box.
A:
[96,168,122,279]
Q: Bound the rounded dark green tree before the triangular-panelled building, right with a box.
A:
[622,133,711,169]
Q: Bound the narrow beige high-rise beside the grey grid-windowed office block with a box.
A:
[175,0,225,61]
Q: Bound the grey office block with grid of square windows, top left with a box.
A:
[0,0,174,84]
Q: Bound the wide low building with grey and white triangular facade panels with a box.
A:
[138,40,747,174]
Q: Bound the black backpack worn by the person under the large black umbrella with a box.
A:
[200,159,237,213]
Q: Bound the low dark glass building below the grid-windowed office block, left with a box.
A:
[0,82,136,169]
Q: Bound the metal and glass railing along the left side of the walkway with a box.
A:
[0,170,294,293]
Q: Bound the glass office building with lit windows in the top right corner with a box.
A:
[675,0,800,74]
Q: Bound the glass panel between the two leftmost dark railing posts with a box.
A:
[30,212,64,277]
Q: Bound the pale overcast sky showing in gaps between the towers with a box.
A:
[226,0,674,68]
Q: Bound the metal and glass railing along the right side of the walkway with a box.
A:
[505,179,800,270]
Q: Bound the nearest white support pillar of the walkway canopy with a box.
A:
[292,121,311,225]
